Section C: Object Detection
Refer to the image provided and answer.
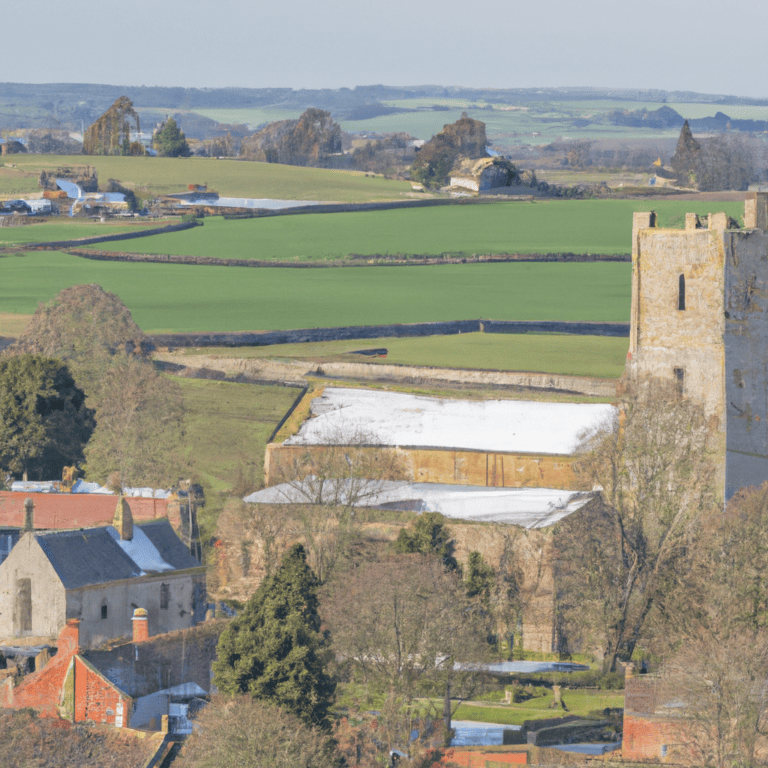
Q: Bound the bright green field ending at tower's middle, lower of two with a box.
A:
[0,251,630,332]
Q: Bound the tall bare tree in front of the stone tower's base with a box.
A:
[556,380,716,671]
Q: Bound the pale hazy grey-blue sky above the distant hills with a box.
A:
[6,0,768,98]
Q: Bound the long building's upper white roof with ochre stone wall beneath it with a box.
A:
[265,387,616,490]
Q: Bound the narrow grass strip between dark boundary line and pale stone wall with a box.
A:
[189,333,629,378]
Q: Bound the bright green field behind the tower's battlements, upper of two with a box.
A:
[81,200,744,261]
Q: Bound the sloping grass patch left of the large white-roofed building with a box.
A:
[174,379,297,533]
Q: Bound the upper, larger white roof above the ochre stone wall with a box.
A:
[285,387,616,455]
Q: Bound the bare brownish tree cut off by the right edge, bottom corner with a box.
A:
[664,484,768,768]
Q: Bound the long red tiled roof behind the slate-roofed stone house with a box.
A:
[0,491,174,530]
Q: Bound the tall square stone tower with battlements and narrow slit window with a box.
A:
[627,192,768,499]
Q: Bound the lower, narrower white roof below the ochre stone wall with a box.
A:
[244,478,594,528]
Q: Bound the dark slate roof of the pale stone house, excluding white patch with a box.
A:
[35,520,200,589]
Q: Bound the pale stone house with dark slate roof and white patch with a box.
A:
[0,497,207,648]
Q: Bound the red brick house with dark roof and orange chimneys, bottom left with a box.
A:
[0,608,224,733]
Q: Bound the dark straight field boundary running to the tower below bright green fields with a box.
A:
[148,320,629,347]
